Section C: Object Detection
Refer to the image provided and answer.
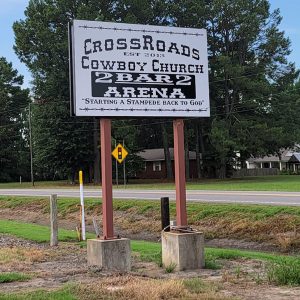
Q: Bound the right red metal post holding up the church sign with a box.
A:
[173,119,187,226]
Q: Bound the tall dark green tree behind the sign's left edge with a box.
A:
[13,0,116,181]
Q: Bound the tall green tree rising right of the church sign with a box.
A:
[172,0,298,178]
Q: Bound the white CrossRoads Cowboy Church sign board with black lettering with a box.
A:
[69,20,210,117]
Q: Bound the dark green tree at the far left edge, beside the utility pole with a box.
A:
[0,57,30,181]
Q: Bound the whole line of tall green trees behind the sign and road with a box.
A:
[0,0,300,183]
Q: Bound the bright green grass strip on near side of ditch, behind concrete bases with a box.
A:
[0,220,300,285]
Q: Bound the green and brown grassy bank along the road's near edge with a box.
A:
[0,196,300,252]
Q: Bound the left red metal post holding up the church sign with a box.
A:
[100,119,114,239]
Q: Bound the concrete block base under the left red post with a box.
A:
[87,238,131,272]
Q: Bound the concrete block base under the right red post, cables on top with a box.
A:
[161,232,205,271]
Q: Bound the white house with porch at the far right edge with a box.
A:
[246,149,300,172]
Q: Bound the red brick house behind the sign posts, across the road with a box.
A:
[136,148,197,179]
